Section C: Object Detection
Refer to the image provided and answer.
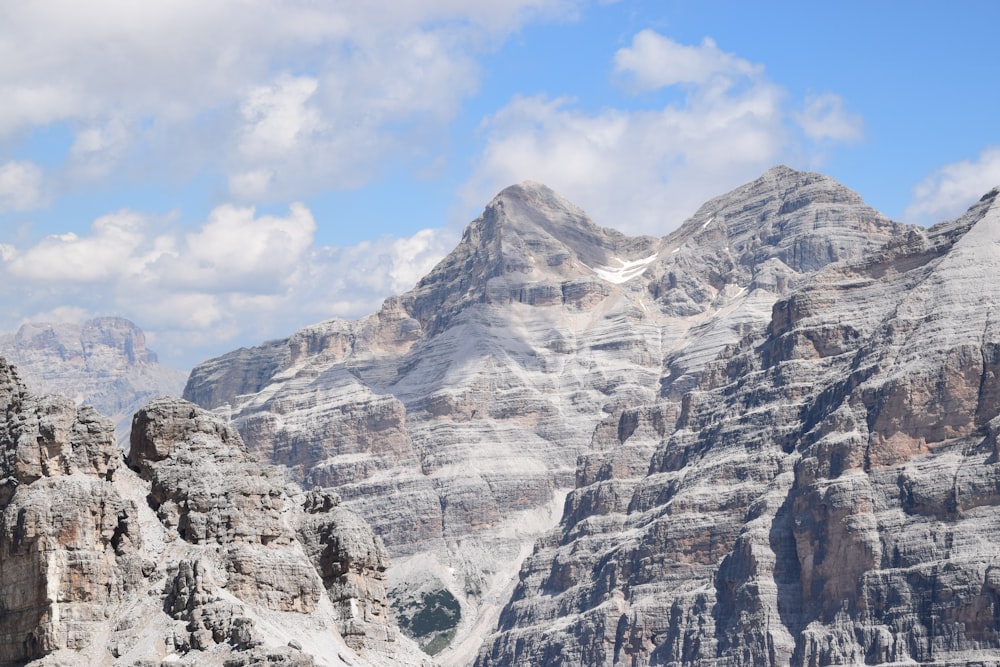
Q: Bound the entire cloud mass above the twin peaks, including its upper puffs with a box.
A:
[465,30,860,235]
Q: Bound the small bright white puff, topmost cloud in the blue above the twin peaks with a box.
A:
[615,30,763,91]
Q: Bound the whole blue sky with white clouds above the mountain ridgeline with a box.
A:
[0,0,1000,368]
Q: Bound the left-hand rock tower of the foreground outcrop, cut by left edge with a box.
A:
[0,359,142,664]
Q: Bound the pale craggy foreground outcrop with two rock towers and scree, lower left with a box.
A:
[0,359,423,666]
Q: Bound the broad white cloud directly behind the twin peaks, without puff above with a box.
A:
[465,84,786,235]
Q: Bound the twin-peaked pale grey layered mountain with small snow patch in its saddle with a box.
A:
[185,168,908,662]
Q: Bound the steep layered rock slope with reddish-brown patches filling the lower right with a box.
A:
[477,185,1000,665]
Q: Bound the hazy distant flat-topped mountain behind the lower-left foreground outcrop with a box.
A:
[0,317,187,444]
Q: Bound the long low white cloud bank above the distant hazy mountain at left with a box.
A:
[0,204,456,365]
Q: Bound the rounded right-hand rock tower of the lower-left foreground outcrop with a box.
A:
[129,399,396,656]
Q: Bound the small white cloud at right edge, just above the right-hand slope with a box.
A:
[903,147,1000,225]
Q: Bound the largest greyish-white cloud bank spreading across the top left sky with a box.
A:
[0,0,577,206]
